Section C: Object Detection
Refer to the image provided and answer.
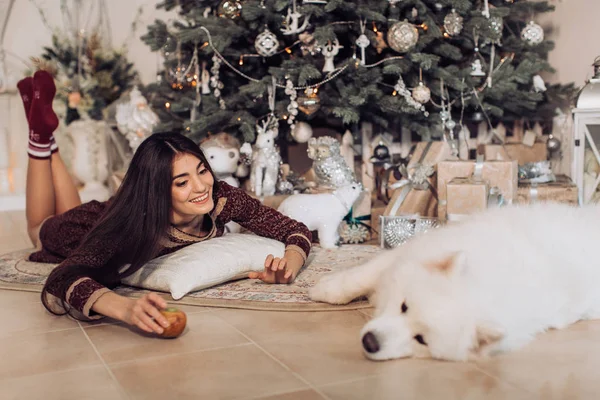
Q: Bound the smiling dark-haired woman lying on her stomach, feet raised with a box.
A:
[17,71,311,334]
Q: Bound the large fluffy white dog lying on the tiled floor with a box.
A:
[309,204,600,361]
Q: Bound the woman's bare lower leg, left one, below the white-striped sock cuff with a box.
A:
[25,157,56,247]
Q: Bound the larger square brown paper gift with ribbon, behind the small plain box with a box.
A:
[437,160,519,220]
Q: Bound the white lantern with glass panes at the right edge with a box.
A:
[571,57,600,205]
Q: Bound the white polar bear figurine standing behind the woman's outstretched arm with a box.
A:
[278,183,363,249]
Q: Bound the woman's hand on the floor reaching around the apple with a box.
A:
[123,293,169,335]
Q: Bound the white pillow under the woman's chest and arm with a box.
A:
[122,233,285,300]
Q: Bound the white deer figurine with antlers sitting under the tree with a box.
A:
[240,118,281,196]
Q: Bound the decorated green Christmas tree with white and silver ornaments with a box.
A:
[143,0,573,145]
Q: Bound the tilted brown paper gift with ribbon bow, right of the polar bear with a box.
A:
[384,141,451,217]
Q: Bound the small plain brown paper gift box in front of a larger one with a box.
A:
[446,178,489,221]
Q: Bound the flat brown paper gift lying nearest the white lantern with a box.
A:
[516,175,579,205]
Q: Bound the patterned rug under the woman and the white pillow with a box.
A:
[0,245,381,311]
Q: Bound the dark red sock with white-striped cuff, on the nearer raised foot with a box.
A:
[27,70,58,159]
